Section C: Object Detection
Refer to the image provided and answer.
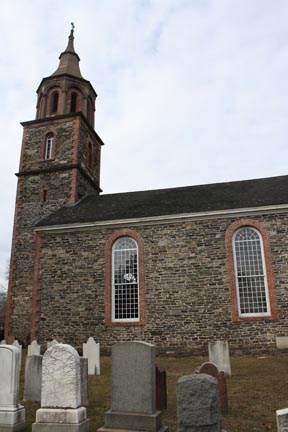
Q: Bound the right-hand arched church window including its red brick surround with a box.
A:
[226,218,278,322]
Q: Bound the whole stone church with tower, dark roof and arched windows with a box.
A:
[5,30,288,354]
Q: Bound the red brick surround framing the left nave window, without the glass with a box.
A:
[105,229,146,327]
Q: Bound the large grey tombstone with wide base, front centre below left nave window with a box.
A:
[98,342,168,432]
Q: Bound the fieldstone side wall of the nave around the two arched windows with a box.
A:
[36,213,288,353]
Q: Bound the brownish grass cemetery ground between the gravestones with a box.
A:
[20,351,288,432]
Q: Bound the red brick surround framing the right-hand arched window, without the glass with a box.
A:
[225,219,279,322]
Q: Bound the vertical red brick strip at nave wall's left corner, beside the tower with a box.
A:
[30,233,42,341]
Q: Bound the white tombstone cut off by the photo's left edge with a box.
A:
[0,344,26,432]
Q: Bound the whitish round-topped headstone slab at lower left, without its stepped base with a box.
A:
[41,344,81,408]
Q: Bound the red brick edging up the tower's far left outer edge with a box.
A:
[4,177,26,340]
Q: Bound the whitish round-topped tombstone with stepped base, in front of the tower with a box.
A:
[32,344,90,432]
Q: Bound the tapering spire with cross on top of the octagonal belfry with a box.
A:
[52,22,83,78]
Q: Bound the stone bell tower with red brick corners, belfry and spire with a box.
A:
[5,24,103,340]
